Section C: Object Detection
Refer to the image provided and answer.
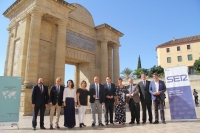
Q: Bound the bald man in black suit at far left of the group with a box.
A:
[31,78,49,130]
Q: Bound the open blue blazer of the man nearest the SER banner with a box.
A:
[149,80,166,100]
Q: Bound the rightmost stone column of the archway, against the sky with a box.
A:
[113,45,120,85]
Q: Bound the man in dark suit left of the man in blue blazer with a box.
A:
[138,73,152,124]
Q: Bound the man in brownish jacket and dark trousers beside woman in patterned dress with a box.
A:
[126,78,140,124]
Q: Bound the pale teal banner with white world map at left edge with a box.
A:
[0,76,22,127]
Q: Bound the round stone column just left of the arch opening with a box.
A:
[54,20,67,83]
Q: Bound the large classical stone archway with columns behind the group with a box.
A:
[4,0,123,115]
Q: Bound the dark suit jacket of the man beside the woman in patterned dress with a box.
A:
[104,83,116,103]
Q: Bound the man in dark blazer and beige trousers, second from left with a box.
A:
[49,77,64,129]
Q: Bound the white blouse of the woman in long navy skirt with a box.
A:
[63,87,77,102]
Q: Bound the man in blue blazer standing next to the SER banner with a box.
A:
[149,73,166,124]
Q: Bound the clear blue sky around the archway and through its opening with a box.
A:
[0,0,200,83]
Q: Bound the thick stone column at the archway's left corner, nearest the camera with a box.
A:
[24,9,43,87]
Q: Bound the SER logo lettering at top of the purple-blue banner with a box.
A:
[167,74,188,83]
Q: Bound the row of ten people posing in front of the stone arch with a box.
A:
[31,73,166,130]
